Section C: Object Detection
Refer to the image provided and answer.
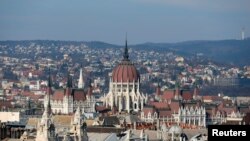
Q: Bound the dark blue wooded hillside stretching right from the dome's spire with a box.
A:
[133,39,250,66]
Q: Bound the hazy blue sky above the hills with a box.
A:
[0,0,250,45]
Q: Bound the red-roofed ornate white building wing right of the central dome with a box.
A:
[140,85,207,128]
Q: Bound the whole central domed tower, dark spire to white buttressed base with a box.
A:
[104,40,147,112]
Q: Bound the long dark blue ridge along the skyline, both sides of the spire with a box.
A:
[0,38,250,66]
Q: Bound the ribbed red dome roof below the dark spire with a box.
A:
[112,60,140,82]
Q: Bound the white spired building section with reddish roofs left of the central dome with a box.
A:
[44,73,96,114]
